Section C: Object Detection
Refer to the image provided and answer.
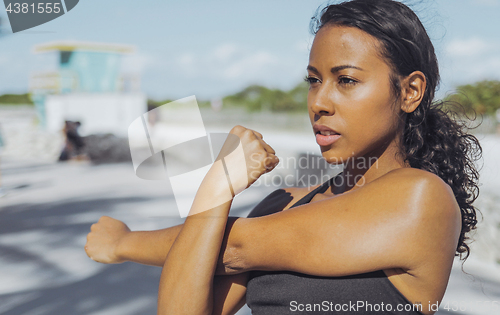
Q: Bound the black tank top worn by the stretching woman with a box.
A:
[246,177,423,315]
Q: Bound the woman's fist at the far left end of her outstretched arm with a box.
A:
[85,216,130,264]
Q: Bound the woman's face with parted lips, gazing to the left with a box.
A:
[307,25,404,164]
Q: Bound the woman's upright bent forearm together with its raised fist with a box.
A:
[158,126,278,315]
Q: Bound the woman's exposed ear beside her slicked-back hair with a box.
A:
[401,71,427,113]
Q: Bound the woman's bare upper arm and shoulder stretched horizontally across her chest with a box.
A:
[221,169,461,277]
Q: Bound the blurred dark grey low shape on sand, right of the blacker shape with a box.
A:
[84,133,132,164]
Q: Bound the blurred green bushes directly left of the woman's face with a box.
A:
[223,82,309,112]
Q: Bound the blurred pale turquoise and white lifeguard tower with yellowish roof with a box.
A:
[30,41,147,136]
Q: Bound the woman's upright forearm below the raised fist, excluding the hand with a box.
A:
[158,163,232,314]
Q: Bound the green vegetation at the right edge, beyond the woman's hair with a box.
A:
[445,81,500,116]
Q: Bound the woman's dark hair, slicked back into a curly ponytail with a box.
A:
[311,0,482,260]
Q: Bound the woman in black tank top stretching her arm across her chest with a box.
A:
[86,0,480,314]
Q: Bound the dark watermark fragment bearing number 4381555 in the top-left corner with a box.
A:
[3,0,79,33]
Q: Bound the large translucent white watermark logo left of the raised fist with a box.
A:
[128,96,246,218]
